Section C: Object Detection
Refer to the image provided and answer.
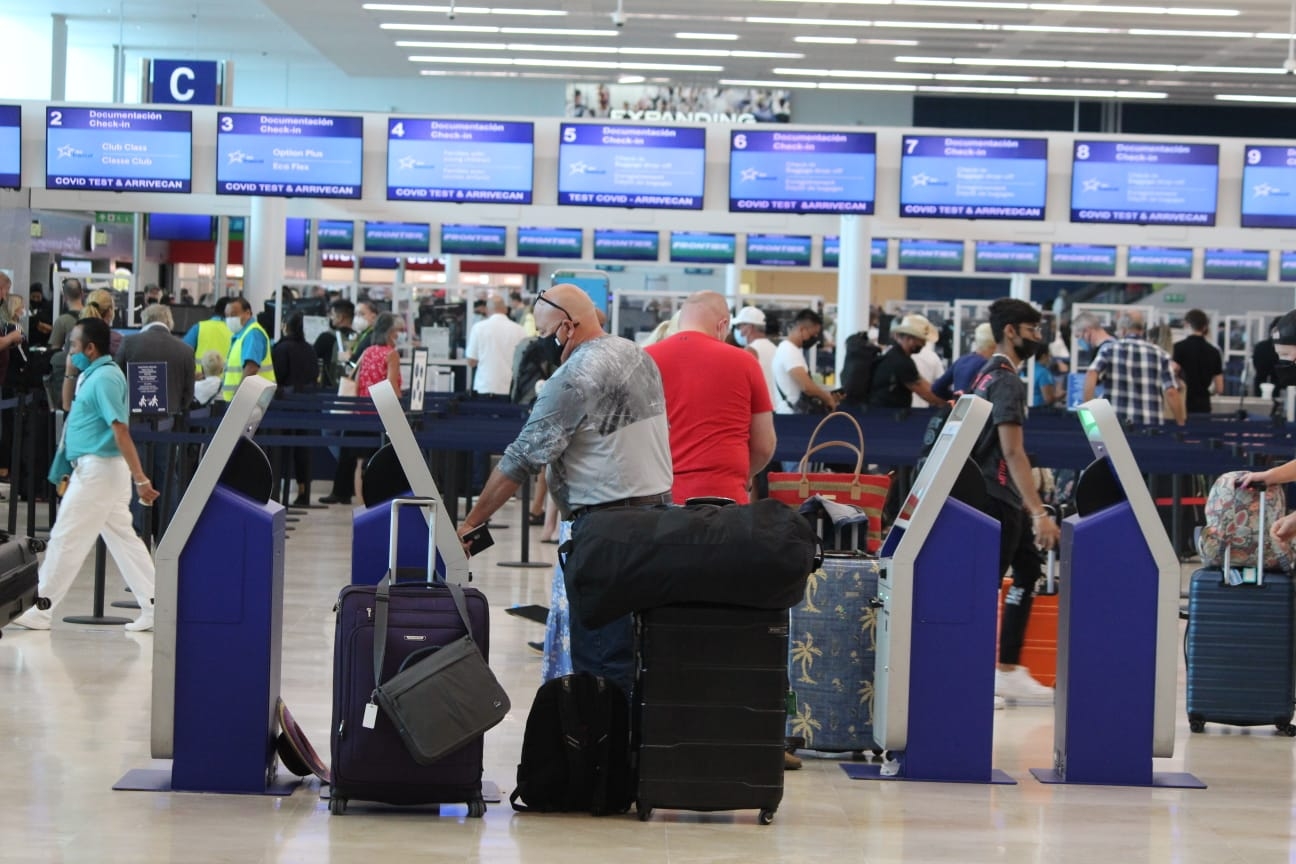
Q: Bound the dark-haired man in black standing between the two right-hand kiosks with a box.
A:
[972,298,1060,703]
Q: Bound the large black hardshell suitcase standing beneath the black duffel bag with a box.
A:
[632,606,788,825]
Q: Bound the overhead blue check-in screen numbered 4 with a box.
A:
[388,117,535,203]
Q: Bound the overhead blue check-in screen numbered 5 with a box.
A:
[559,123,706,210]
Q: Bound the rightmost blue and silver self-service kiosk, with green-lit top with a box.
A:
[1030,399,1204,788]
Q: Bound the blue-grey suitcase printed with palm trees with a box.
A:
[788,552,879,753]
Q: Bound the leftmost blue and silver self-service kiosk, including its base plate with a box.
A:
[113,377,297,794]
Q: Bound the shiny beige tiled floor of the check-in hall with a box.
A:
[0,506,1296,864]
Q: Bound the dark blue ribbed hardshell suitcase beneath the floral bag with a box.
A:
[1183,484,1296,736]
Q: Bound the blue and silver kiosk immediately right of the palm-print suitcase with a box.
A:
[851,396,1012,782]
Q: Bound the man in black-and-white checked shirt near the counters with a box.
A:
[1085,312,1185,426]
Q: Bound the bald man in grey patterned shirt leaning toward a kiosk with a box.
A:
[459,285,673,693]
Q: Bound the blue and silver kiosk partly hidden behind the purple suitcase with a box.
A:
[351,381,470,584]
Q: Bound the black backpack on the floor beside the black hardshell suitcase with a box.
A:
[508,672,634,816]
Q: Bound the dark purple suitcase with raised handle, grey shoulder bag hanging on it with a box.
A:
[329,499,490,817]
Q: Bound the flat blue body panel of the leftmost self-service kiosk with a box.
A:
[171,484,285,795]
